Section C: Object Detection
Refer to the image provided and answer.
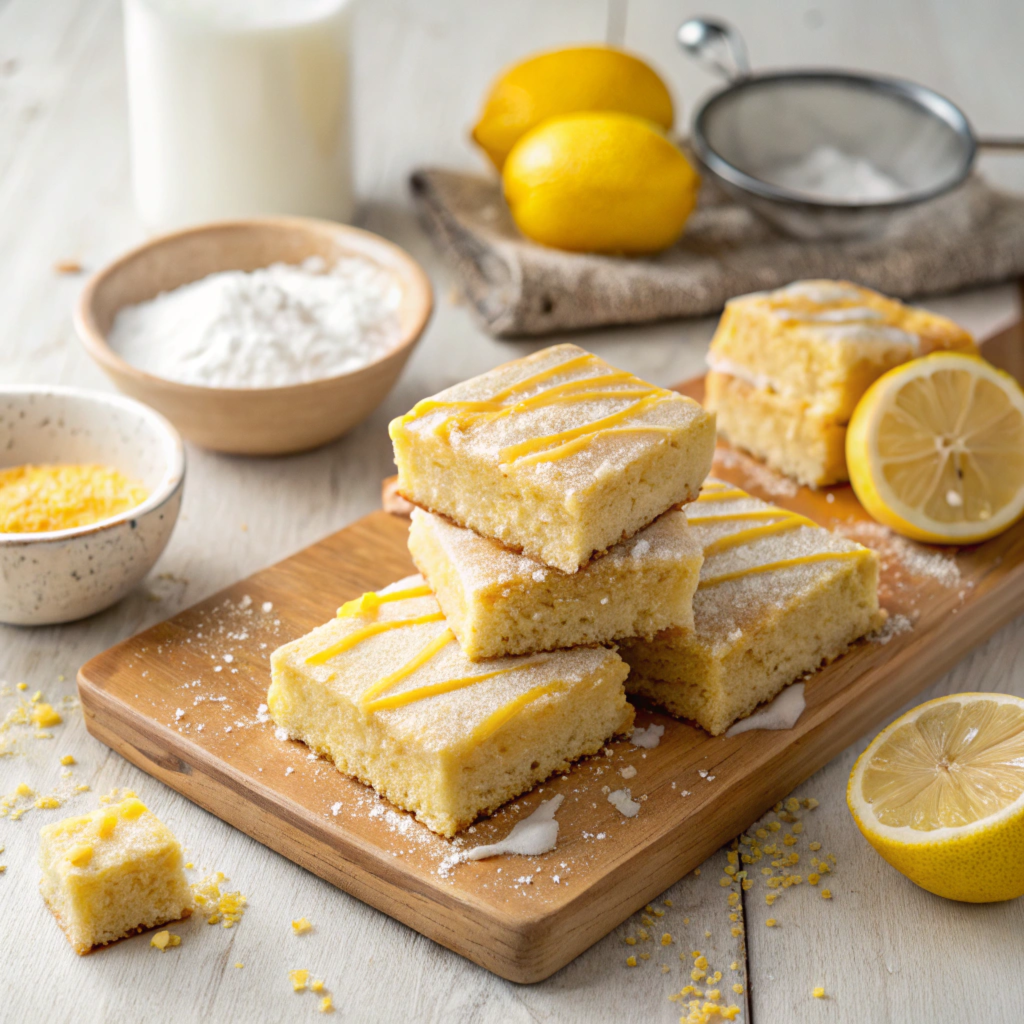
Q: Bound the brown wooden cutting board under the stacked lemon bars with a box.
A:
[78,319,1024,982]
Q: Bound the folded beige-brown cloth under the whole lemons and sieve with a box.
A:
[411,169,1024,337]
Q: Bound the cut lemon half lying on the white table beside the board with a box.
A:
[846,693,1024,903]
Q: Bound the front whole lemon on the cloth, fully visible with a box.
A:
[502,114,700,254]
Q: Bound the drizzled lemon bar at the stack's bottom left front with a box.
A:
[267,577,633,836]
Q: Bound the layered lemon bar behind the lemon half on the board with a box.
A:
[706,281,976,486]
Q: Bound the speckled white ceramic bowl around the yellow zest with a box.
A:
[0,387,185,626]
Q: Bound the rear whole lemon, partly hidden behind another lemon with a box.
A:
[473,46,673,170]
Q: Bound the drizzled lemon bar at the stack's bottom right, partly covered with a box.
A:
[621,480,884,736]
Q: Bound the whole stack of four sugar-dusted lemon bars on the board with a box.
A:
[267,345,879,837]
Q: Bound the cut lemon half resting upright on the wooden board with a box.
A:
[846,352,1024,544]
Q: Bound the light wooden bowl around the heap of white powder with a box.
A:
[75,217,433,455]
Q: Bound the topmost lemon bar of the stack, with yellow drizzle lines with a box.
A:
[390,345,715,572]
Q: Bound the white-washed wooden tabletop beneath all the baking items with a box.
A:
[0,0,1024,1024]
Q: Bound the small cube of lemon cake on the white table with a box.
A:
[39,797,193,954]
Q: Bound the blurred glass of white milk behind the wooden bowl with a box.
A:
[124,0,353,230]
